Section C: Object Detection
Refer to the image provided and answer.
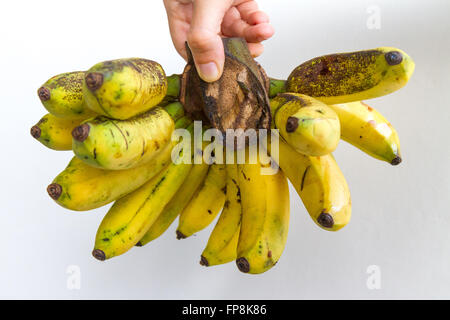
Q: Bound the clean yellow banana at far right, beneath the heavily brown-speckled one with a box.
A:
[330,101,402,165]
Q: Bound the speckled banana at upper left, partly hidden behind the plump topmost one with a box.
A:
[38,71,96,119]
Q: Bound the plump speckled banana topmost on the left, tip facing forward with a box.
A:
[83,58,167,120]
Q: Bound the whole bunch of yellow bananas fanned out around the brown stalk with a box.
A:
[31,41,414,273]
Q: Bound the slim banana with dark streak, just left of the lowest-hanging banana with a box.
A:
[200,164,242,266]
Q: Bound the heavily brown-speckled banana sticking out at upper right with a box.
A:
[286,47,414,104]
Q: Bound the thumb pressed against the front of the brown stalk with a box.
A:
[187,0,233,82]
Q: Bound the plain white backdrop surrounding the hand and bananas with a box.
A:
[0,0,450,299]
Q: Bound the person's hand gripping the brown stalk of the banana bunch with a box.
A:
[164,0,274,82]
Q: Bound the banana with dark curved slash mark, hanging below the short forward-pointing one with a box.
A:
[267,139,351,231]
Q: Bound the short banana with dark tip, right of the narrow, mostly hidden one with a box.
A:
[176,163,226,239]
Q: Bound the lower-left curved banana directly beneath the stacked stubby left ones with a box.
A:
[47,141,172,211]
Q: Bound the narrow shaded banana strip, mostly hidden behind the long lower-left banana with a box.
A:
[137,162,209,246]
